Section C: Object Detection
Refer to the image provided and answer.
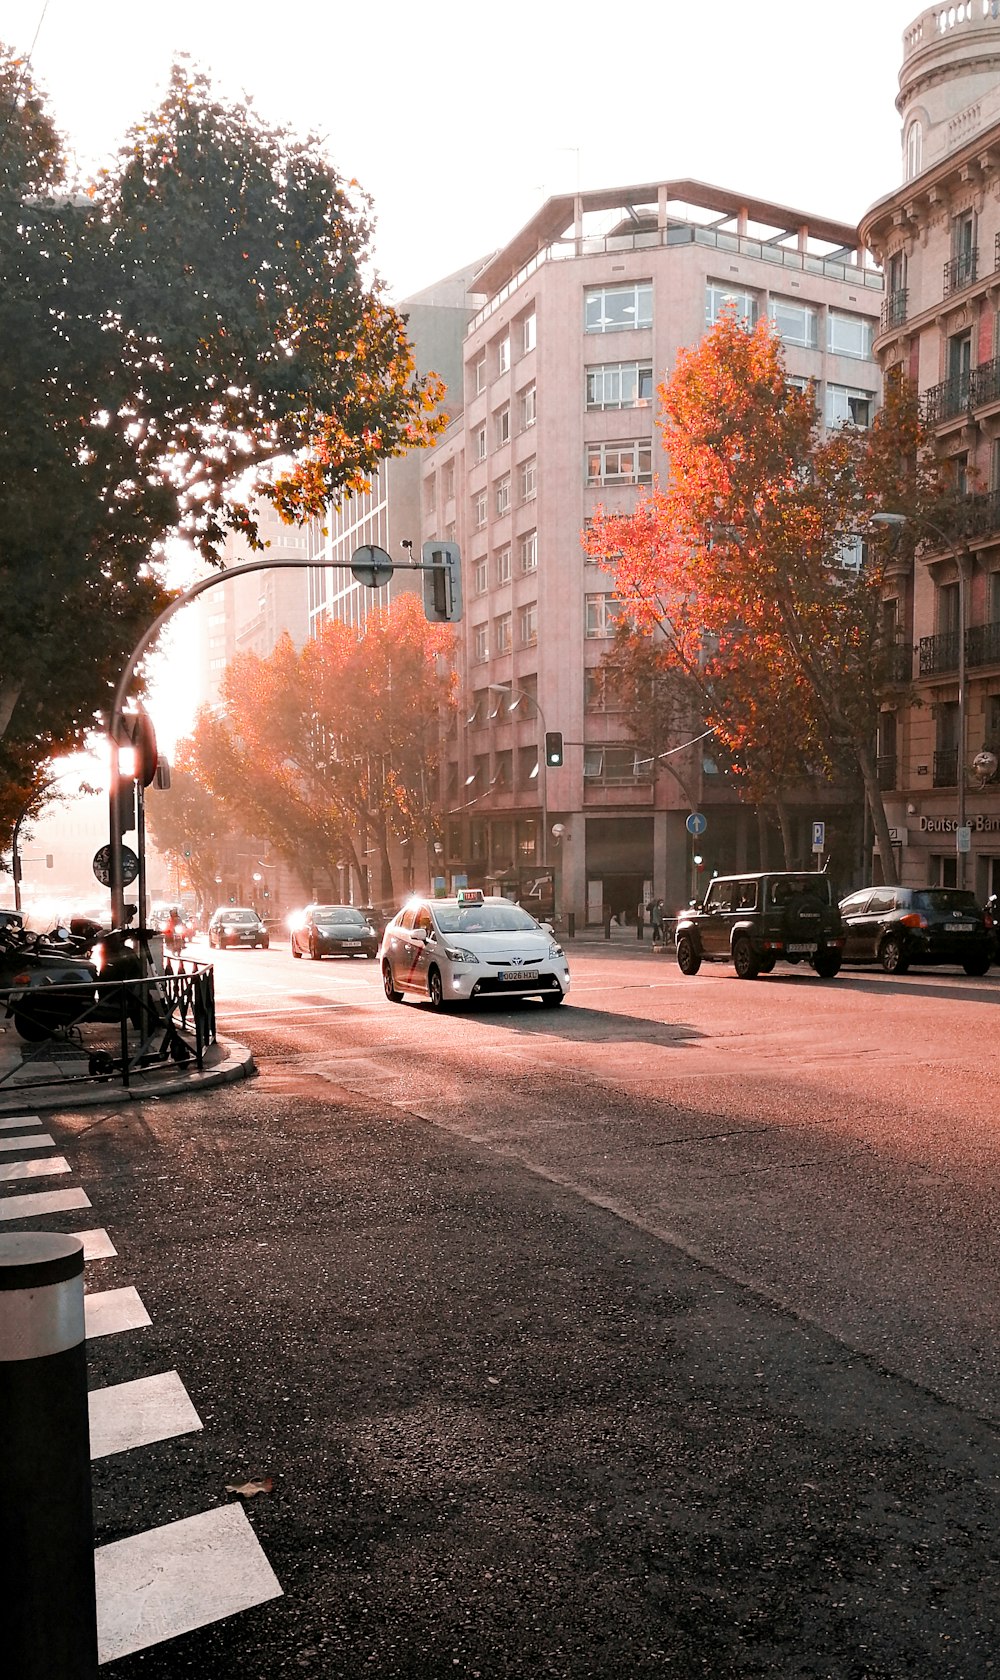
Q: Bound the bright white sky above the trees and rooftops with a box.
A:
[0,0,921,301]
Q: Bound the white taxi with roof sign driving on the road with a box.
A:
[378,889,570,1010]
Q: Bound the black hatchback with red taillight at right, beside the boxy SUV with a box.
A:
[840,887,992,974]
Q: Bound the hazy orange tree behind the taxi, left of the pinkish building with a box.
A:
[192,593,455,902]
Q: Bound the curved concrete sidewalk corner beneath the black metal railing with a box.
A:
[0,1020,257,1116]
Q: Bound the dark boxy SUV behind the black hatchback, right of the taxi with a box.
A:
[676,870,844,979]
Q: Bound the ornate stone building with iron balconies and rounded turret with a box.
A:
[861,0,1000,897]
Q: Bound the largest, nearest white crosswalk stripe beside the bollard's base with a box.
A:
[94,1505,281,1663]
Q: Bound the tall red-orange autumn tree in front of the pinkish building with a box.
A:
[585,312,933,879]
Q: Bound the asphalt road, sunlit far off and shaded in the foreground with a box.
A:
[39,946,1000,1680]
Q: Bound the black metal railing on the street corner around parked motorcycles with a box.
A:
[0,961,215,1094]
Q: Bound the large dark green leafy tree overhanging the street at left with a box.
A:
[0,49,444,833]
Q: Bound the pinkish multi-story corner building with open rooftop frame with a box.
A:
[422,180,882,921]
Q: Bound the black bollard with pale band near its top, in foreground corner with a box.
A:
[0,1231,97,1680]
